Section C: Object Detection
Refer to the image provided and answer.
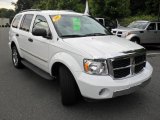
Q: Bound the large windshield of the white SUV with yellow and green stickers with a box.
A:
[51,15,111,38]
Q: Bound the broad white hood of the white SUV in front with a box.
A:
[63,35,143,59]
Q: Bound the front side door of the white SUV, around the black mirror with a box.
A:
[28,15,52,72]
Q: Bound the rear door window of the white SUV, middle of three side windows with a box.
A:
[20,14,33,32]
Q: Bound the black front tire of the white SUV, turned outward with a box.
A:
[59,65,80,106]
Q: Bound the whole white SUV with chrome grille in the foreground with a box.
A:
[9,10,153,105]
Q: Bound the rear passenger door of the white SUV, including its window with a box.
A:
[18,14,34,60]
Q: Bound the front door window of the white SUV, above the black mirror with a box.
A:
[32,15,51,36]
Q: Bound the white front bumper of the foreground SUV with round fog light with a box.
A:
[76,62,153,99]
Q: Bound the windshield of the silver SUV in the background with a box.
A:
[128,22,148,29]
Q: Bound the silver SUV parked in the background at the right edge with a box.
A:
[112,21,160,44]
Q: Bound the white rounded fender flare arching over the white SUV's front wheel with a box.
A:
[49,52,83,76]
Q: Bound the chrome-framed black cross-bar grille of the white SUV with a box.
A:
[108,50,146,79]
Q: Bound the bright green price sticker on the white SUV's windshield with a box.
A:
[72,18,81,31]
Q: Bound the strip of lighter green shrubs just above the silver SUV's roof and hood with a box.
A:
[120,15,157,26]
